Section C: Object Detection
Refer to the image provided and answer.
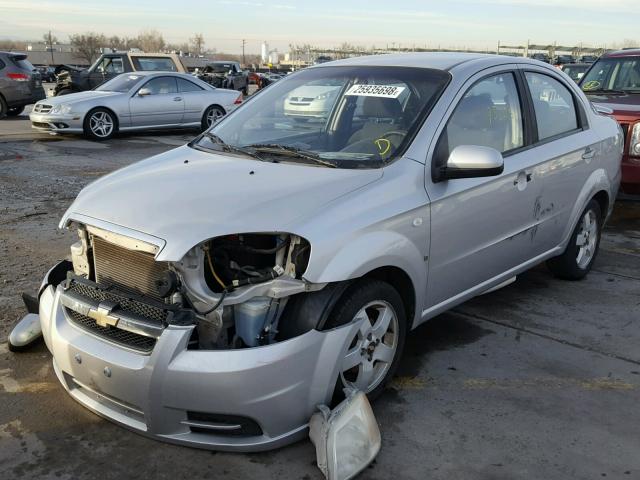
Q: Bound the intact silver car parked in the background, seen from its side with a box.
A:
[29,72,242,140]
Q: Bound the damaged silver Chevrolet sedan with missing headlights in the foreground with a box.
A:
[33,53,623,451]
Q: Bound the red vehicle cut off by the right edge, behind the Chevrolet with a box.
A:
[580,49,640,194]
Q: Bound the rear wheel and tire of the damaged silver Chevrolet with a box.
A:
[547,199,602,280]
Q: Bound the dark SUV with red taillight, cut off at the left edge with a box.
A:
[0,52,46,118]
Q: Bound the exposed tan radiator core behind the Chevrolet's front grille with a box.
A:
[92,236,167,301]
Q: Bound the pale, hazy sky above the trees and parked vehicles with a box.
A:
[0,0,640,53]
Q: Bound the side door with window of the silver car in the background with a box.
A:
[129,76,184,127]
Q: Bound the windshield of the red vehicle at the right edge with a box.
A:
[580,57,640,93]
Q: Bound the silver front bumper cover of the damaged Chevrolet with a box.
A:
[40,286,358,451]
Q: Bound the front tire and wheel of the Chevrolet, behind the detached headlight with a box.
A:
[325,279,407,404]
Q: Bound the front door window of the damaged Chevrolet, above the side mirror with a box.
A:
[437,73,524,164]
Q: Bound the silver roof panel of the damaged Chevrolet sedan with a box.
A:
[310,52,537,71]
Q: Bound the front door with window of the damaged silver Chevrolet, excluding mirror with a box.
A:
[425,67,545,312]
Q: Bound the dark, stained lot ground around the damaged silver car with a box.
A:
[0,128,640,480]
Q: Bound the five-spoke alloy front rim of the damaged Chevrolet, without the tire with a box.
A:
[340,300,400,393]
